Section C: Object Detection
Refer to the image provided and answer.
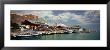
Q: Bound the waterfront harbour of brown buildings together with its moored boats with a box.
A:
[11,15,93,37]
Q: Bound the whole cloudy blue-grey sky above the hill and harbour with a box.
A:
[11,10,100,27]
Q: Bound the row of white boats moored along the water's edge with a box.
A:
[11,26,94,37]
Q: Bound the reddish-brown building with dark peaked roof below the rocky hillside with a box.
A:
[21,20,49,31]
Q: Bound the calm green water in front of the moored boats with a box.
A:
[12,32,100,40]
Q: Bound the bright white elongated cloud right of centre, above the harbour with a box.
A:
[56,12,87,24]
